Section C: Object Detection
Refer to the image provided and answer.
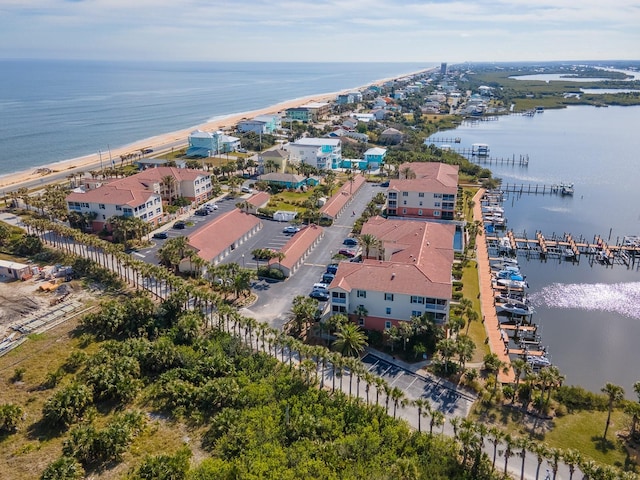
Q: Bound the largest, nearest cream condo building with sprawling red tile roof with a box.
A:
[329,217,455,331]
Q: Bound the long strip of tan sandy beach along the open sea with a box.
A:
[0,67,436,193]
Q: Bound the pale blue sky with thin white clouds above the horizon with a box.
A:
[0,0,640,63]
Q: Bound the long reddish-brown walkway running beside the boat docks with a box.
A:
[473,188,515,383]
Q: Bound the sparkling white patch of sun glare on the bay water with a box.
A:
[530,282,640,319]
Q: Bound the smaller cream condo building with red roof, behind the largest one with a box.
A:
[387,162,458,220]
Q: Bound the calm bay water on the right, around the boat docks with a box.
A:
[435,106,640,398]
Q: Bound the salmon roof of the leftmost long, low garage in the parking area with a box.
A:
[189,208,261,262]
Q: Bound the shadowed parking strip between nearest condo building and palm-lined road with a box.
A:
[362,353,475,417]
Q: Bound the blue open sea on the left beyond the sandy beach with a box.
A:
[0,60,434,175]
